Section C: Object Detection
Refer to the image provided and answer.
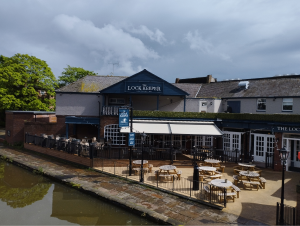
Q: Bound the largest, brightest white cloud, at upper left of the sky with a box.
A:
[53,14,159,68]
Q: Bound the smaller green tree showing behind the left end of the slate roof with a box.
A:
[58,65,97,87]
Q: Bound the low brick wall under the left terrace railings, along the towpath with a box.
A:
[24,143,91,167]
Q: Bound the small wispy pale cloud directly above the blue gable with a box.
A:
[126,25,167,45]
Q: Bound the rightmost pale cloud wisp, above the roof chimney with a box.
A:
[184,30,230,60]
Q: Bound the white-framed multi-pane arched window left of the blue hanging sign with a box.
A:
[104,124,126,145]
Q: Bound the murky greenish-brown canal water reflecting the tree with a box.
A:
[0,160,158,226]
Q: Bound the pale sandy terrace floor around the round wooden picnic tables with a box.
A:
[94,158,300,225]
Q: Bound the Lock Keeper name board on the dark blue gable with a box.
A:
[125,82,163,93]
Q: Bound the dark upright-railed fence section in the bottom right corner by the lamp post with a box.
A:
[276,202,300,226]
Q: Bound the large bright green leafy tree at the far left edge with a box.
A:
[0,53,57,111]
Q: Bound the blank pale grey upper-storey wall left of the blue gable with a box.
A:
[55,94,102,116]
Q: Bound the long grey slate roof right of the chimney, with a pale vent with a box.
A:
[197,75,300,98]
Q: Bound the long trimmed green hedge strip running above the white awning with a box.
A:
[133,111,300,123]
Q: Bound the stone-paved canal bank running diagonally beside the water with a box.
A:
[0,146,265,226]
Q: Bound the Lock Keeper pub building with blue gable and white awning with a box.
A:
[12,70,300,171]
